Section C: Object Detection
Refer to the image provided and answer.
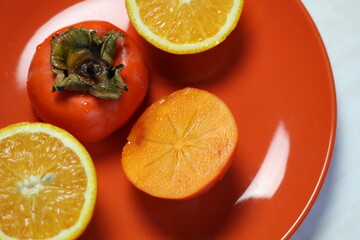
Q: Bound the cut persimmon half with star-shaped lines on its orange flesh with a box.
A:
[122,88,238,199]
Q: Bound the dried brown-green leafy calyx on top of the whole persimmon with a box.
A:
[50,27,127,99]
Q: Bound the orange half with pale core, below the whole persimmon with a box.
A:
[0,123,97,240]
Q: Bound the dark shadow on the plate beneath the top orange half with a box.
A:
[127,17,250,87]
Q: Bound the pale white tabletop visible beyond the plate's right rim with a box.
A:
[291,0,360,240]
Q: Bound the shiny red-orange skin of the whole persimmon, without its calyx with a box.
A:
[27,21,148,142]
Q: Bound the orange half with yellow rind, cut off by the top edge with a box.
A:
[125,0,243,54]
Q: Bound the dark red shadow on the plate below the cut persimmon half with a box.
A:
[133,160,244,239]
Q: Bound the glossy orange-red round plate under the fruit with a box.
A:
[0,0,336,239]
